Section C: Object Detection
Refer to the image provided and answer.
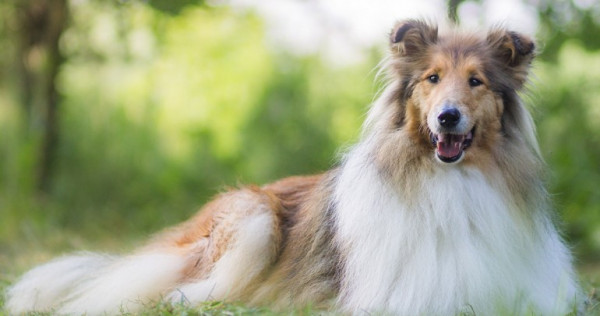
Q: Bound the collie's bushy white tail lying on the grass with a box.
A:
[6,252,185,315]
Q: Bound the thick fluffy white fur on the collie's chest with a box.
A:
[335,151,577,315]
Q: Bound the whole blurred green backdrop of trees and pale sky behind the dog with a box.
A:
[0,0,600,298]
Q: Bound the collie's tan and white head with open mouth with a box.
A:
[390,20,535,163]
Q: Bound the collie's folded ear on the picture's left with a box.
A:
[390,20,438,56]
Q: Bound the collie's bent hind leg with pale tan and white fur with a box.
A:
[167,188,281,304]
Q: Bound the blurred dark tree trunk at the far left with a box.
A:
[16,0,68,193]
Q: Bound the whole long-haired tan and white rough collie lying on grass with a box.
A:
[6,20,580,315]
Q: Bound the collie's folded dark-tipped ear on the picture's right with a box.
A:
[487,30,535,67]
